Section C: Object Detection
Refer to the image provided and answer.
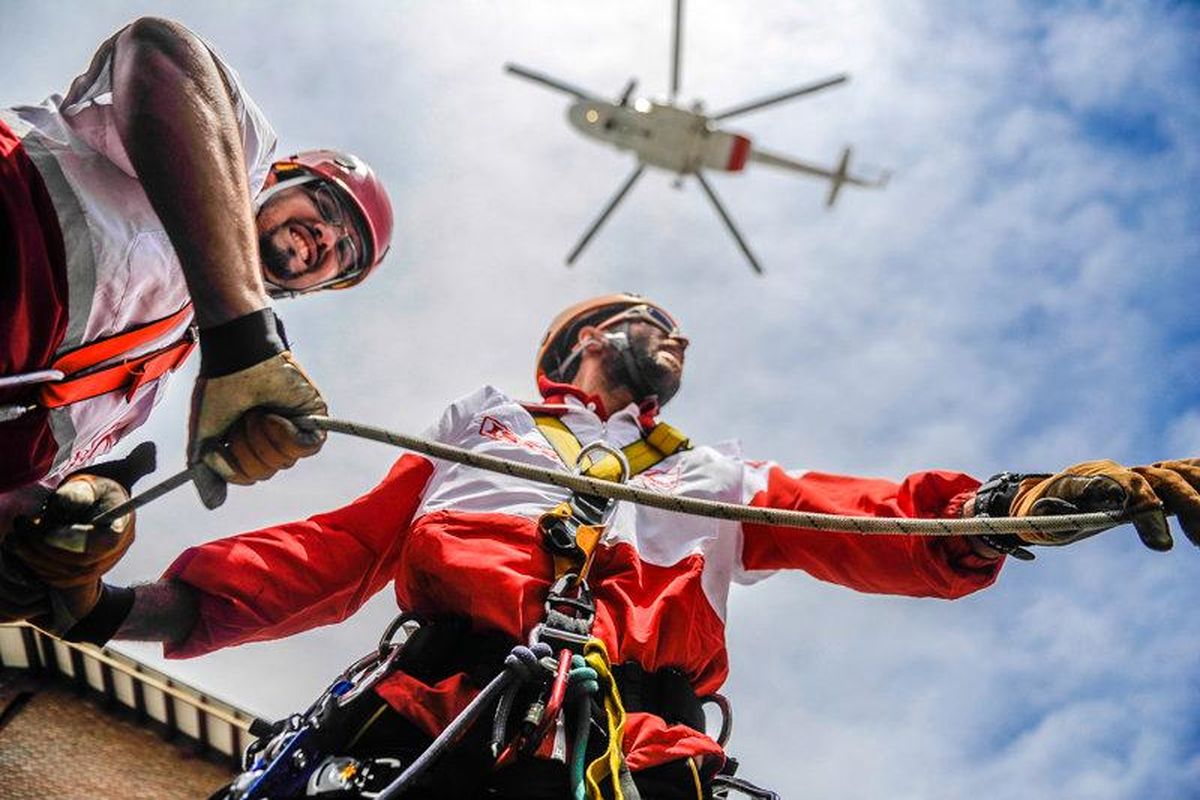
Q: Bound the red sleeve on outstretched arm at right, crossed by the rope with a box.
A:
[742,465,1002,597]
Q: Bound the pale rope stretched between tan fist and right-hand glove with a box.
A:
[293,416,1129,536]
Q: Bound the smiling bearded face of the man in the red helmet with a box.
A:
[256,182,364,290]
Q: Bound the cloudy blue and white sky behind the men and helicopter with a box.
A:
[0,0,1200,800]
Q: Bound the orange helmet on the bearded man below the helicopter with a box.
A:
[535,293,679,381]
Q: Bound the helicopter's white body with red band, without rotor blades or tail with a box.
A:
[566,98,751,174]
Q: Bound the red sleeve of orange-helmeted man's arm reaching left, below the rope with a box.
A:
[163,456,433,658]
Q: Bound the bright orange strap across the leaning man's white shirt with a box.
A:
[37,303,196,408]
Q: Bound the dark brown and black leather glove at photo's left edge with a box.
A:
[0,443,155,634]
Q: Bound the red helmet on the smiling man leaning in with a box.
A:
[269,150,391,289]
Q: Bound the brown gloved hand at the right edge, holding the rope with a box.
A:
[1009,459,1200,551]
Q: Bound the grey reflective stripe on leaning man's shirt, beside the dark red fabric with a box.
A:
[20,131,96,351]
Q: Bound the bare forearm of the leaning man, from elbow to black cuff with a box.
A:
[113,19,266,327]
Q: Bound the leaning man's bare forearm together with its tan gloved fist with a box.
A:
[113,18,328,509]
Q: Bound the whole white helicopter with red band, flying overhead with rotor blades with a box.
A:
[504,0,889,275]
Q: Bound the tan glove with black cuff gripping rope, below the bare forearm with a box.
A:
[187,308,328,509]
